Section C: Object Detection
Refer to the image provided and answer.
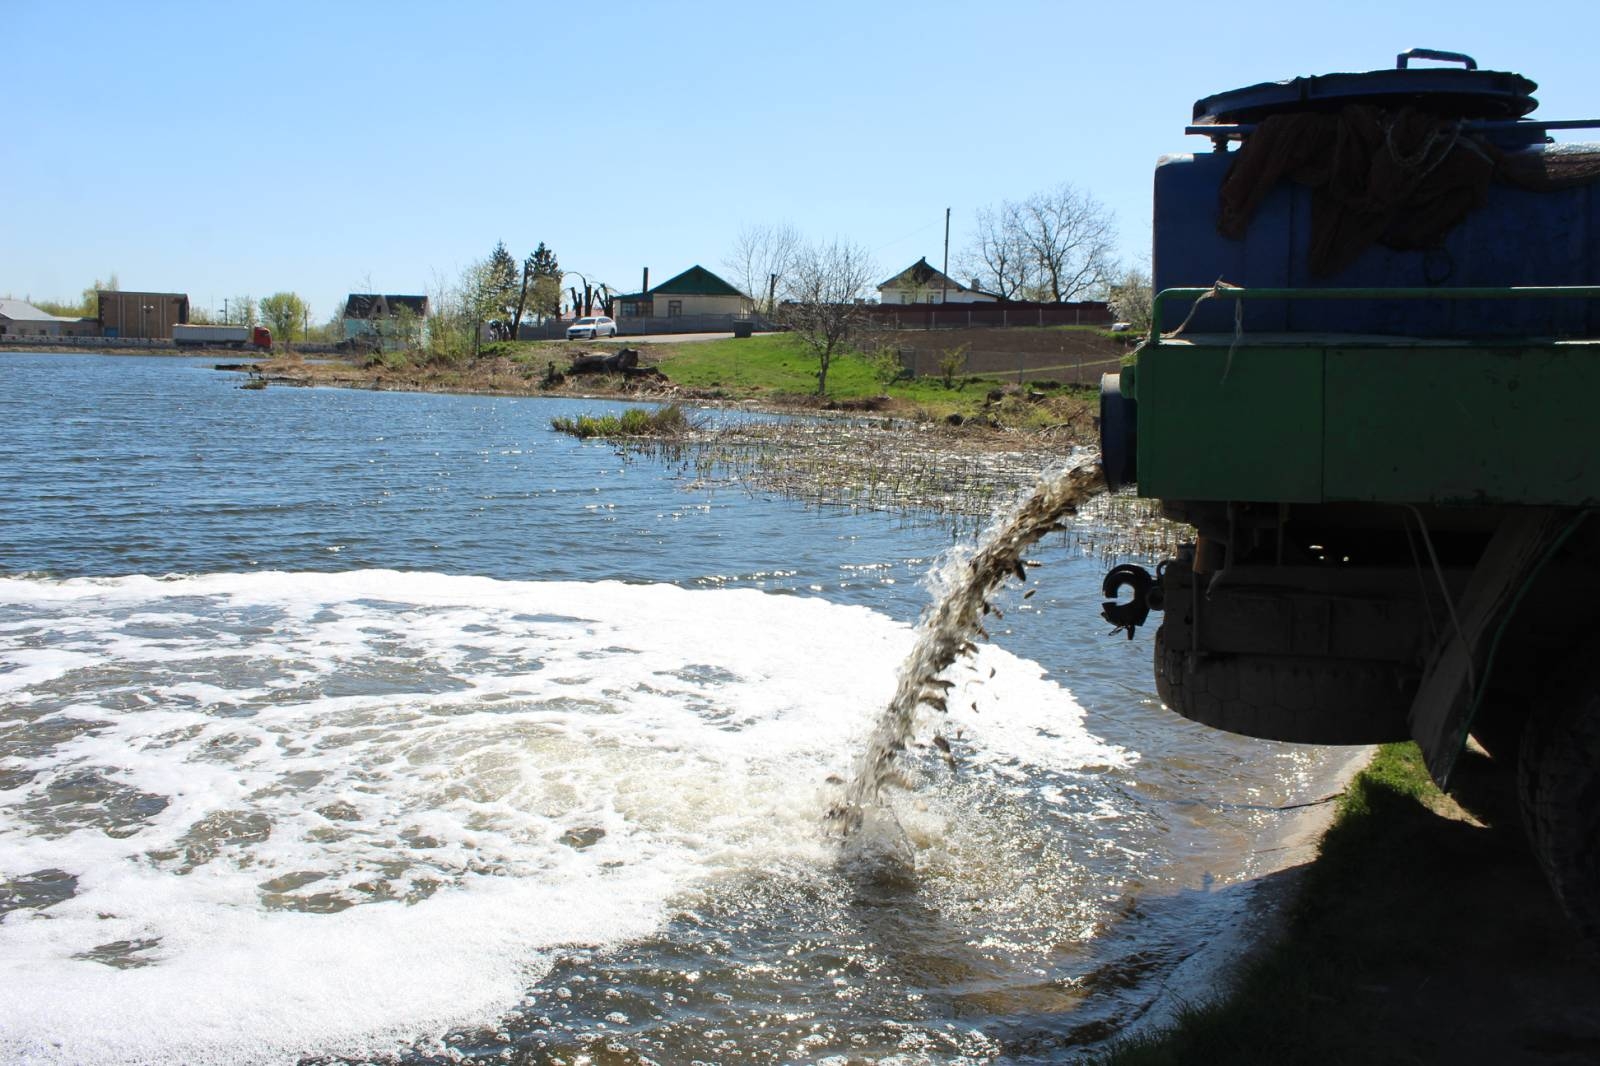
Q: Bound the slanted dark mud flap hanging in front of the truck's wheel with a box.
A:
[1408,507,1571,787]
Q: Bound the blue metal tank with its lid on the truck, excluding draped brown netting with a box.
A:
[1152,58,1600,336]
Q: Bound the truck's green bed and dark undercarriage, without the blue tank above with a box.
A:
[1101,287,1600,944]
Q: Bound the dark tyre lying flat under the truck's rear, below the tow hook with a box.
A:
[1155,624,1411,744]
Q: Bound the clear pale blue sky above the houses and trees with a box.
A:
[0,0,1600,319]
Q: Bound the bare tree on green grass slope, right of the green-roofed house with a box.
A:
[779,240,874,395]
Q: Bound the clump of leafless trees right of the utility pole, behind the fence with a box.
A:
[965,182,1117,303]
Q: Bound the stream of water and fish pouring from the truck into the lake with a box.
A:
[827,461,1106,845]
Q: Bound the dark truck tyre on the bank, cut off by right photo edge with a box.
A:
[1517,658,1600,949]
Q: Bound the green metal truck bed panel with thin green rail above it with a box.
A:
[1122,287,1600,506]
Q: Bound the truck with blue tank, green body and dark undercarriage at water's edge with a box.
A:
[1101,50,1600,946]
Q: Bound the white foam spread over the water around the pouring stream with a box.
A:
[0,571,1128,1063]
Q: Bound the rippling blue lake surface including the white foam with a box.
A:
[0,354,1341,1063]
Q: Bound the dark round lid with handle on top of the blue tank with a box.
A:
[1194,48,1539,125]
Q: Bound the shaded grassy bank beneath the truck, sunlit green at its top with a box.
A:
[1098,743,1600,1066]
